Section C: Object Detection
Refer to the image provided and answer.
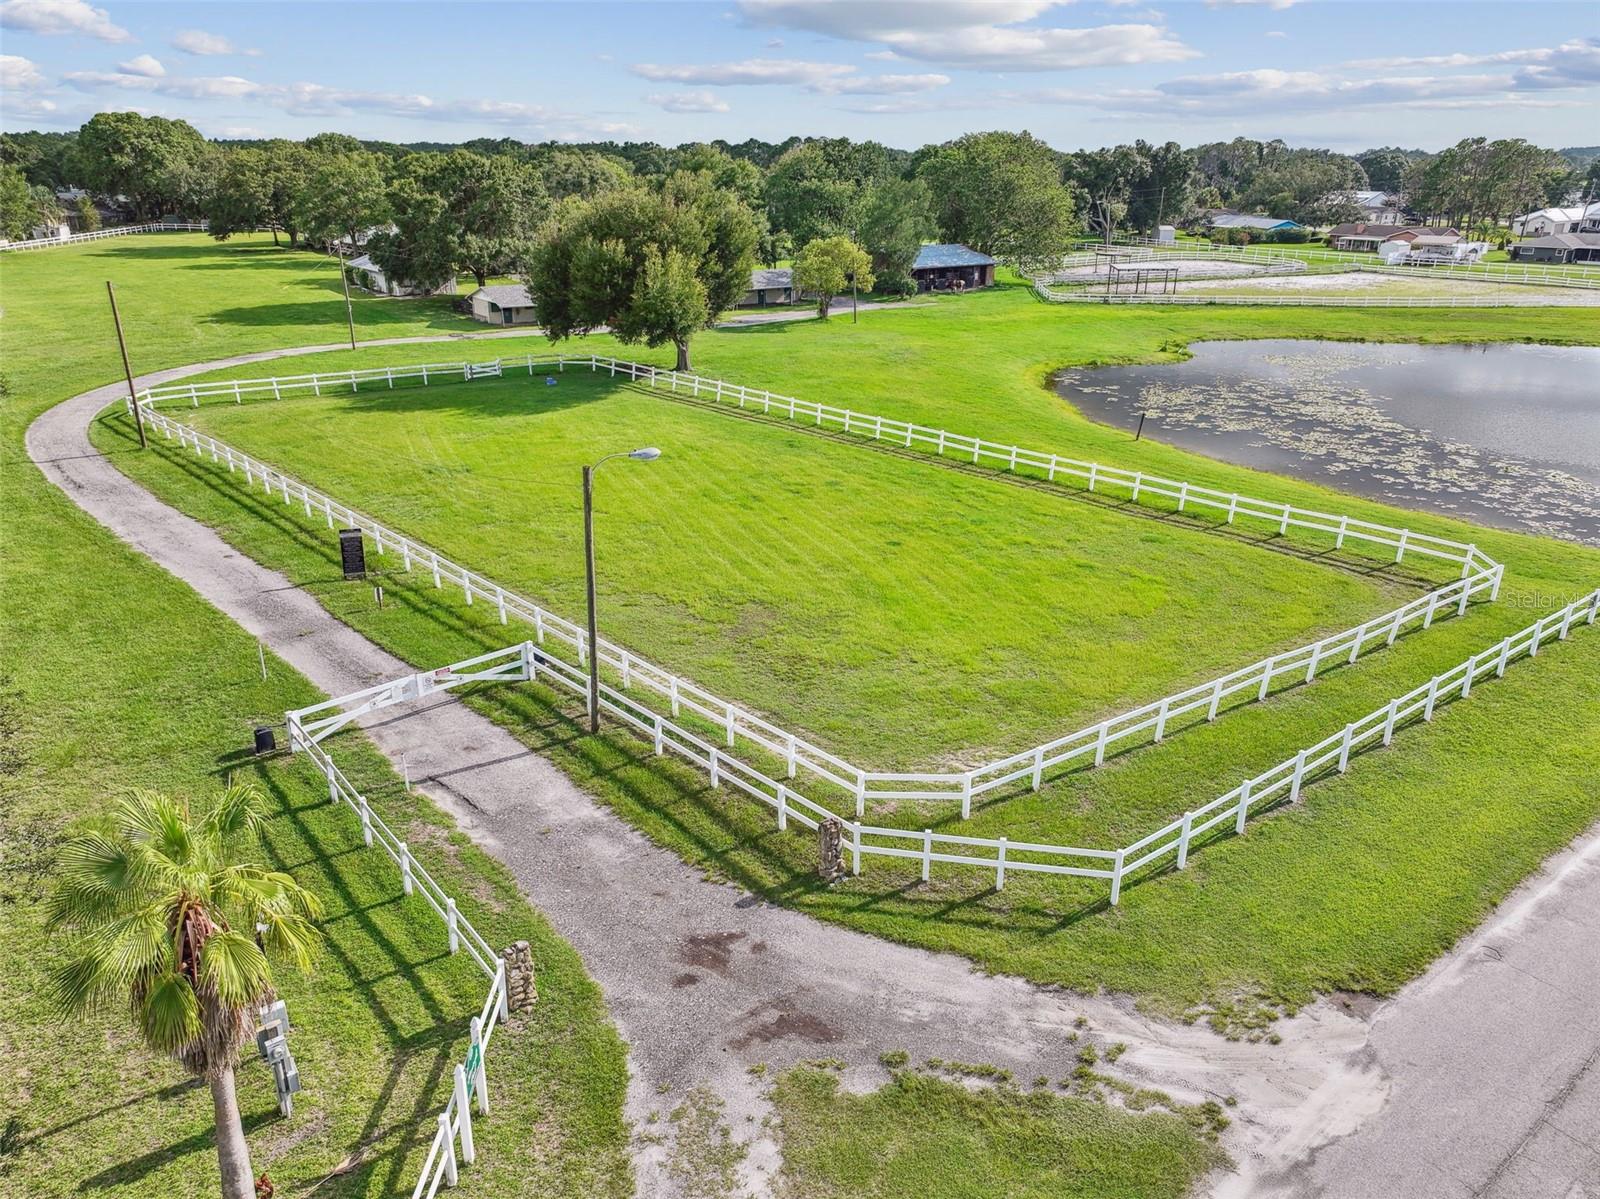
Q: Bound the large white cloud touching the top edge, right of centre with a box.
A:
[739,0,1198,70]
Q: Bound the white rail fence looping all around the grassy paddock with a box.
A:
[128,355,1504,818]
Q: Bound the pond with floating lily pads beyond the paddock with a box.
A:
[1056,339,1600,546]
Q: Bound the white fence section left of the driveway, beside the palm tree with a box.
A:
[288,712,507,1199]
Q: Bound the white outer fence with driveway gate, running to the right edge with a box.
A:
[288,587,1600,904]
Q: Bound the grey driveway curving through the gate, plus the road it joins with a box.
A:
[27,335,1600,1199]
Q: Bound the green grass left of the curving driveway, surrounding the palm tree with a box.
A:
[0,235,632,1199]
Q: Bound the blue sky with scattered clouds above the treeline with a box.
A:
[0,0,1600,150]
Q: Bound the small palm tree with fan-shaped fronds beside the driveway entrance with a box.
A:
[50,784,322,1199]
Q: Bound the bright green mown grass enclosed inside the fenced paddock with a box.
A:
[173,370,1414,768]
